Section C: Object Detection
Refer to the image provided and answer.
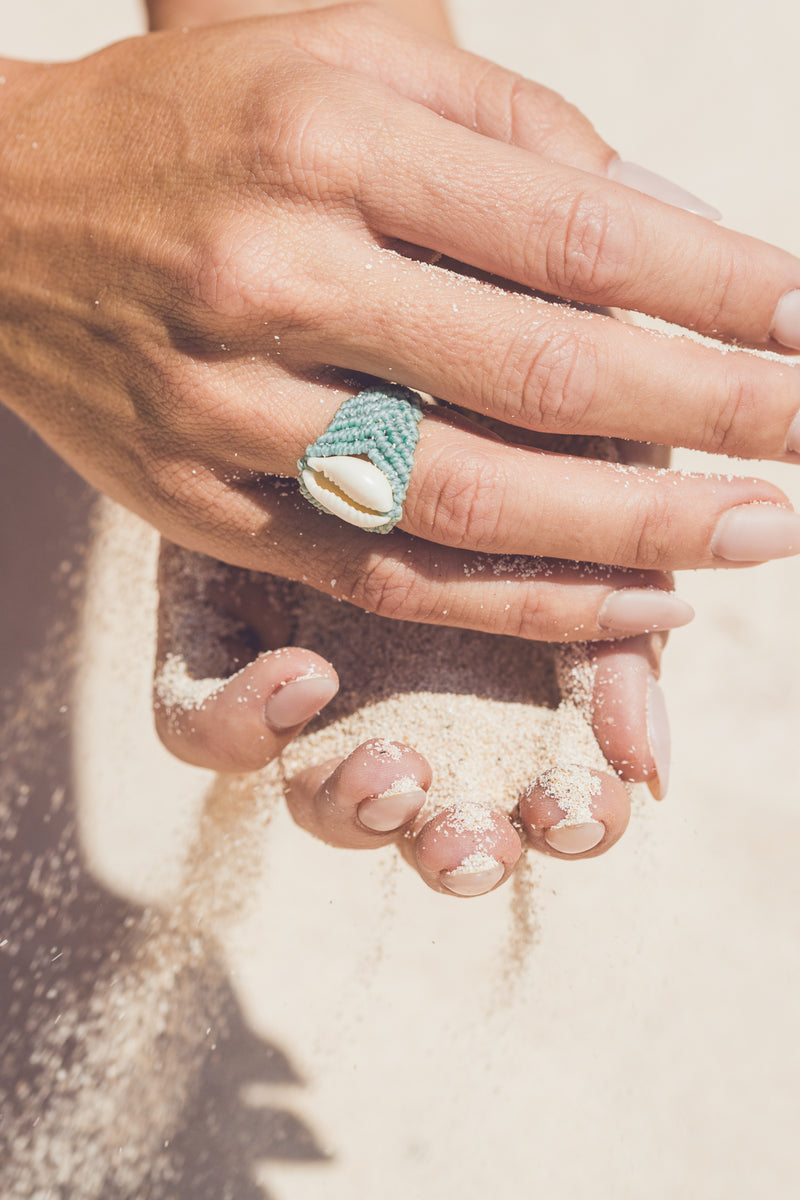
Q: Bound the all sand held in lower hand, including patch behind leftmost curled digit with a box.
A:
[156,552,606,823]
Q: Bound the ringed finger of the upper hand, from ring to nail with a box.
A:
[402,418,800,571]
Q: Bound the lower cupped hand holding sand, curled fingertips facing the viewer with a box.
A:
[154,542,668,895]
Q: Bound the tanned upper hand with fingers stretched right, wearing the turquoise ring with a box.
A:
[0,5,800,640]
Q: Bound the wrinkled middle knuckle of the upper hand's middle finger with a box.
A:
[509,325,599,433]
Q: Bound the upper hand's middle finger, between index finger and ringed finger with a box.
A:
[320,245,800,461]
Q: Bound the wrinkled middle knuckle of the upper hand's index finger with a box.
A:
[542,188,636,304]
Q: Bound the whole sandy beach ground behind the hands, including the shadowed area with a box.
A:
[0,0,800,1200]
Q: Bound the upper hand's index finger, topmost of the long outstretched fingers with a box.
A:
[335,81,800,347]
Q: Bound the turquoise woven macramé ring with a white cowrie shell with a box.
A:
[297,384,422,533]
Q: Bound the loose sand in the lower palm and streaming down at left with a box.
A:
[4,505,618,1200]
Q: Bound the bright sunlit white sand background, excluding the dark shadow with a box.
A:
[0,0,800,1200]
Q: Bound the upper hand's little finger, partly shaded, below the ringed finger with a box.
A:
[173,465,705,641]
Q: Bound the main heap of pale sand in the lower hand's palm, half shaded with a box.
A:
[260,581,607,828]
